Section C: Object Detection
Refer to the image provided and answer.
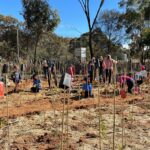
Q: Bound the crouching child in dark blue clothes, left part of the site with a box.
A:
[31,74,41,93]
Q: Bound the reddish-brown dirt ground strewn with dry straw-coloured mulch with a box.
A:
[0,80,150,150]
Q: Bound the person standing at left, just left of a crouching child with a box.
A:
[11,65,21,92]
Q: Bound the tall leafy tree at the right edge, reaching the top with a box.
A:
[119,0,150,63]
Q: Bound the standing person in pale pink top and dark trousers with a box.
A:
[103,55,117,83]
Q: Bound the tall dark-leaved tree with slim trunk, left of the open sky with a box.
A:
[22,0,60,63]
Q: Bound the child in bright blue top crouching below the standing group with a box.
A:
[82,78,93,98]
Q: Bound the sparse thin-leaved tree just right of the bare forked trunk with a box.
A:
[96,10,123,53]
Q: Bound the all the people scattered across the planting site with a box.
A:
[0,55,147,97]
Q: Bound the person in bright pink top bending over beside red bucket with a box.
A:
[119,73,135,94]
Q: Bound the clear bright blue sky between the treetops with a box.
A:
[0,0,120,37]
